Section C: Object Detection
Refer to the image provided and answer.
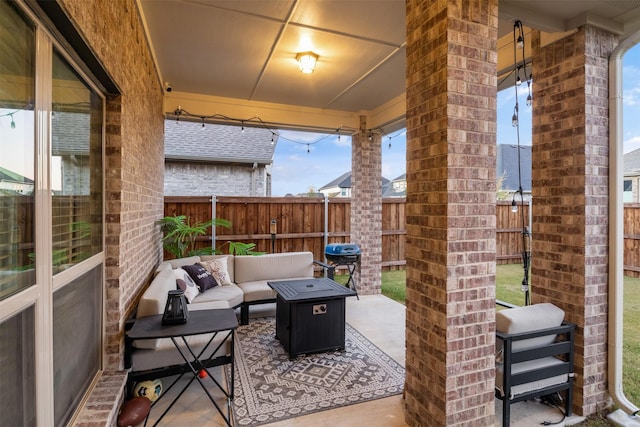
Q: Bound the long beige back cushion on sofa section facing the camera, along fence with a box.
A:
[235,252,313,284]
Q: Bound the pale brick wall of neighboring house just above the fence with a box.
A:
[164,162,271,197]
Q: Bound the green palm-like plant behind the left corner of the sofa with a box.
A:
[158,215,231,258]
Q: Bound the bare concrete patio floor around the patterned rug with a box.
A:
[141,295,584,427]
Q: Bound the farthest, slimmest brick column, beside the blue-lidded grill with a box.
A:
[351,117,382,294]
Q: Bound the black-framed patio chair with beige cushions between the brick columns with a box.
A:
[496,303,576,426]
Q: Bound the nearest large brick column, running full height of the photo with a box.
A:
[405,0,498,426]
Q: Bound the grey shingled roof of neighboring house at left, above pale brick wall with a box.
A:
[164,120,278,164]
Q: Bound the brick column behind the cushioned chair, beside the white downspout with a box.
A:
[532,26,616,415]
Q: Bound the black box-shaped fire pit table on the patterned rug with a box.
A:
[267,278,356,359]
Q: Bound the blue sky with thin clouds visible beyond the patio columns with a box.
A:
[272,45,640,196]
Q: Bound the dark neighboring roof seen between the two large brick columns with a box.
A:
[496,144,531,192]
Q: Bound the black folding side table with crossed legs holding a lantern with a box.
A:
[127,308,238,426]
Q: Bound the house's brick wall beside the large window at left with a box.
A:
[63,0,164,369]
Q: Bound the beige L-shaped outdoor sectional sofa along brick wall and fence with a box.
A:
[125,252,334,395]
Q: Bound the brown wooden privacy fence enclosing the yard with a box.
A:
[164,197,640,276]
